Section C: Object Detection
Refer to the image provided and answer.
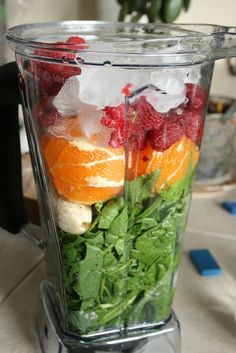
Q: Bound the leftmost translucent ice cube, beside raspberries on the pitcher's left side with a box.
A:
[53,76,81,116]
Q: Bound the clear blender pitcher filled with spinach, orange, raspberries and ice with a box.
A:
[1,21,236,353]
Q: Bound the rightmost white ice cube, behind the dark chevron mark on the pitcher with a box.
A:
[146,71,186,113]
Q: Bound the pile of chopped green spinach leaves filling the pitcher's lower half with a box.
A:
[60,170,193,333]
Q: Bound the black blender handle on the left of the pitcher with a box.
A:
[0,62,44,247]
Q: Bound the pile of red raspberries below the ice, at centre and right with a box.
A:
[101,83,207,152]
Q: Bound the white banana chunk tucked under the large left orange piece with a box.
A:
[56,199,92,234]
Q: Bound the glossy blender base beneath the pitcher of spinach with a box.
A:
[38,283,180,353]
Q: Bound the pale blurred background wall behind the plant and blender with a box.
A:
[5,0,236,97]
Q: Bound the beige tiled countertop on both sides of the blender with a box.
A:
[0,191,236,353]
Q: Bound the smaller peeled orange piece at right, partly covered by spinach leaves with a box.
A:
[146,136,199,190]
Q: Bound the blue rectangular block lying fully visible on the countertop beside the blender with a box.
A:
[189,249,221,276]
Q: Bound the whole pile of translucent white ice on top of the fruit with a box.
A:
[53,66,195,137]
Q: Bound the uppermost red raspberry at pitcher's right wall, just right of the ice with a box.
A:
[186,83,207,113]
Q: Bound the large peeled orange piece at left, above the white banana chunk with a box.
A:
[41,135,125,204]
